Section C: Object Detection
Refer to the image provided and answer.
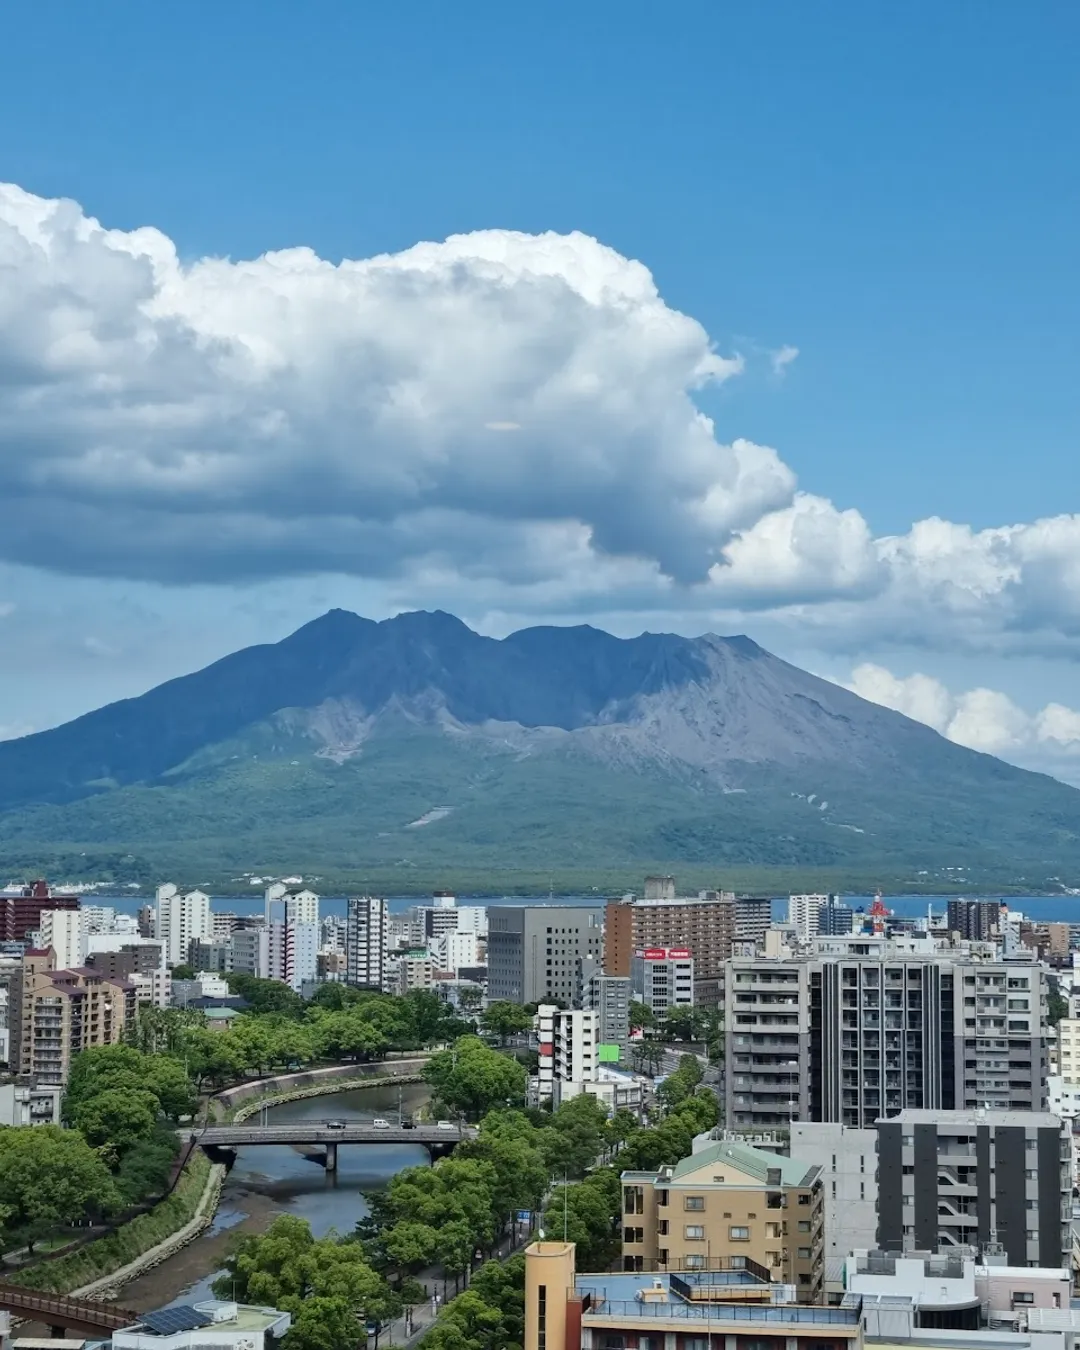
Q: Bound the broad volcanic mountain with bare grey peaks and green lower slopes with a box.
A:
[0,610,1080,875]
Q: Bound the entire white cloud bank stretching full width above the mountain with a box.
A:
[0,185,1080,661]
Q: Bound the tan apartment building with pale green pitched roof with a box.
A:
[622,1139,825,1303]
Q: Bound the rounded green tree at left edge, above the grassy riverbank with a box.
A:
[0,1125,120,1250]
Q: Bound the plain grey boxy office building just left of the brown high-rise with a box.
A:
[487,905,603,1007]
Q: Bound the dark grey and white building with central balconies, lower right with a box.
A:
[878,1111,1072,1268]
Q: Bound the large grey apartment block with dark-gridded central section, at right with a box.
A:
[725,938,1049,1129]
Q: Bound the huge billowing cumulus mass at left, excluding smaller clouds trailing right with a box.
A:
[0,186,777,581]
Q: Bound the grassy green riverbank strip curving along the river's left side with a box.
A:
[9,1149,211,1293]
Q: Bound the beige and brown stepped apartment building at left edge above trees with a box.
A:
[11,948,136,1084]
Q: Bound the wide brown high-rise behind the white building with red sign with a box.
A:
[603,878,772,983]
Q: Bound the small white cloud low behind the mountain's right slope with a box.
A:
[846,662,1080,786]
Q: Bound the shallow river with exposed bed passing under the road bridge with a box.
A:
[119,1083,429,1312]
